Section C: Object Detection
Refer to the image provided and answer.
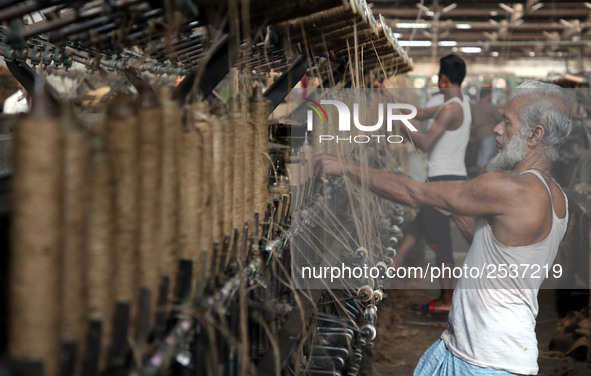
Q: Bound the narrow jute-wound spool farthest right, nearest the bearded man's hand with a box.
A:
[250,86,270,234]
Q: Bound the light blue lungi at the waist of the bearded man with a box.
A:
[413,338,517,376]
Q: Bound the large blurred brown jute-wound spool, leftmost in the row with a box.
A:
[9,90,63,376]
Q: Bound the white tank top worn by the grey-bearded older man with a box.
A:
[441,170,568,375]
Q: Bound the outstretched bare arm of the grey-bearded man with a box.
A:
[315,155,523,216]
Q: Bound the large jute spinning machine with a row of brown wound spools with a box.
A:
[0,0,412,376]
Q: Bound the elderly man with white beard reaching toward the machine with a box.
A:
[315,81,572,376]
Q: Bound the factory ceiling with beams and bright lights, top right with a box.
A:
[372,0,591,61]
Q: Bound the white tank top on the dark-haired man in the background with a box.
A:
[427,95,472,178]
